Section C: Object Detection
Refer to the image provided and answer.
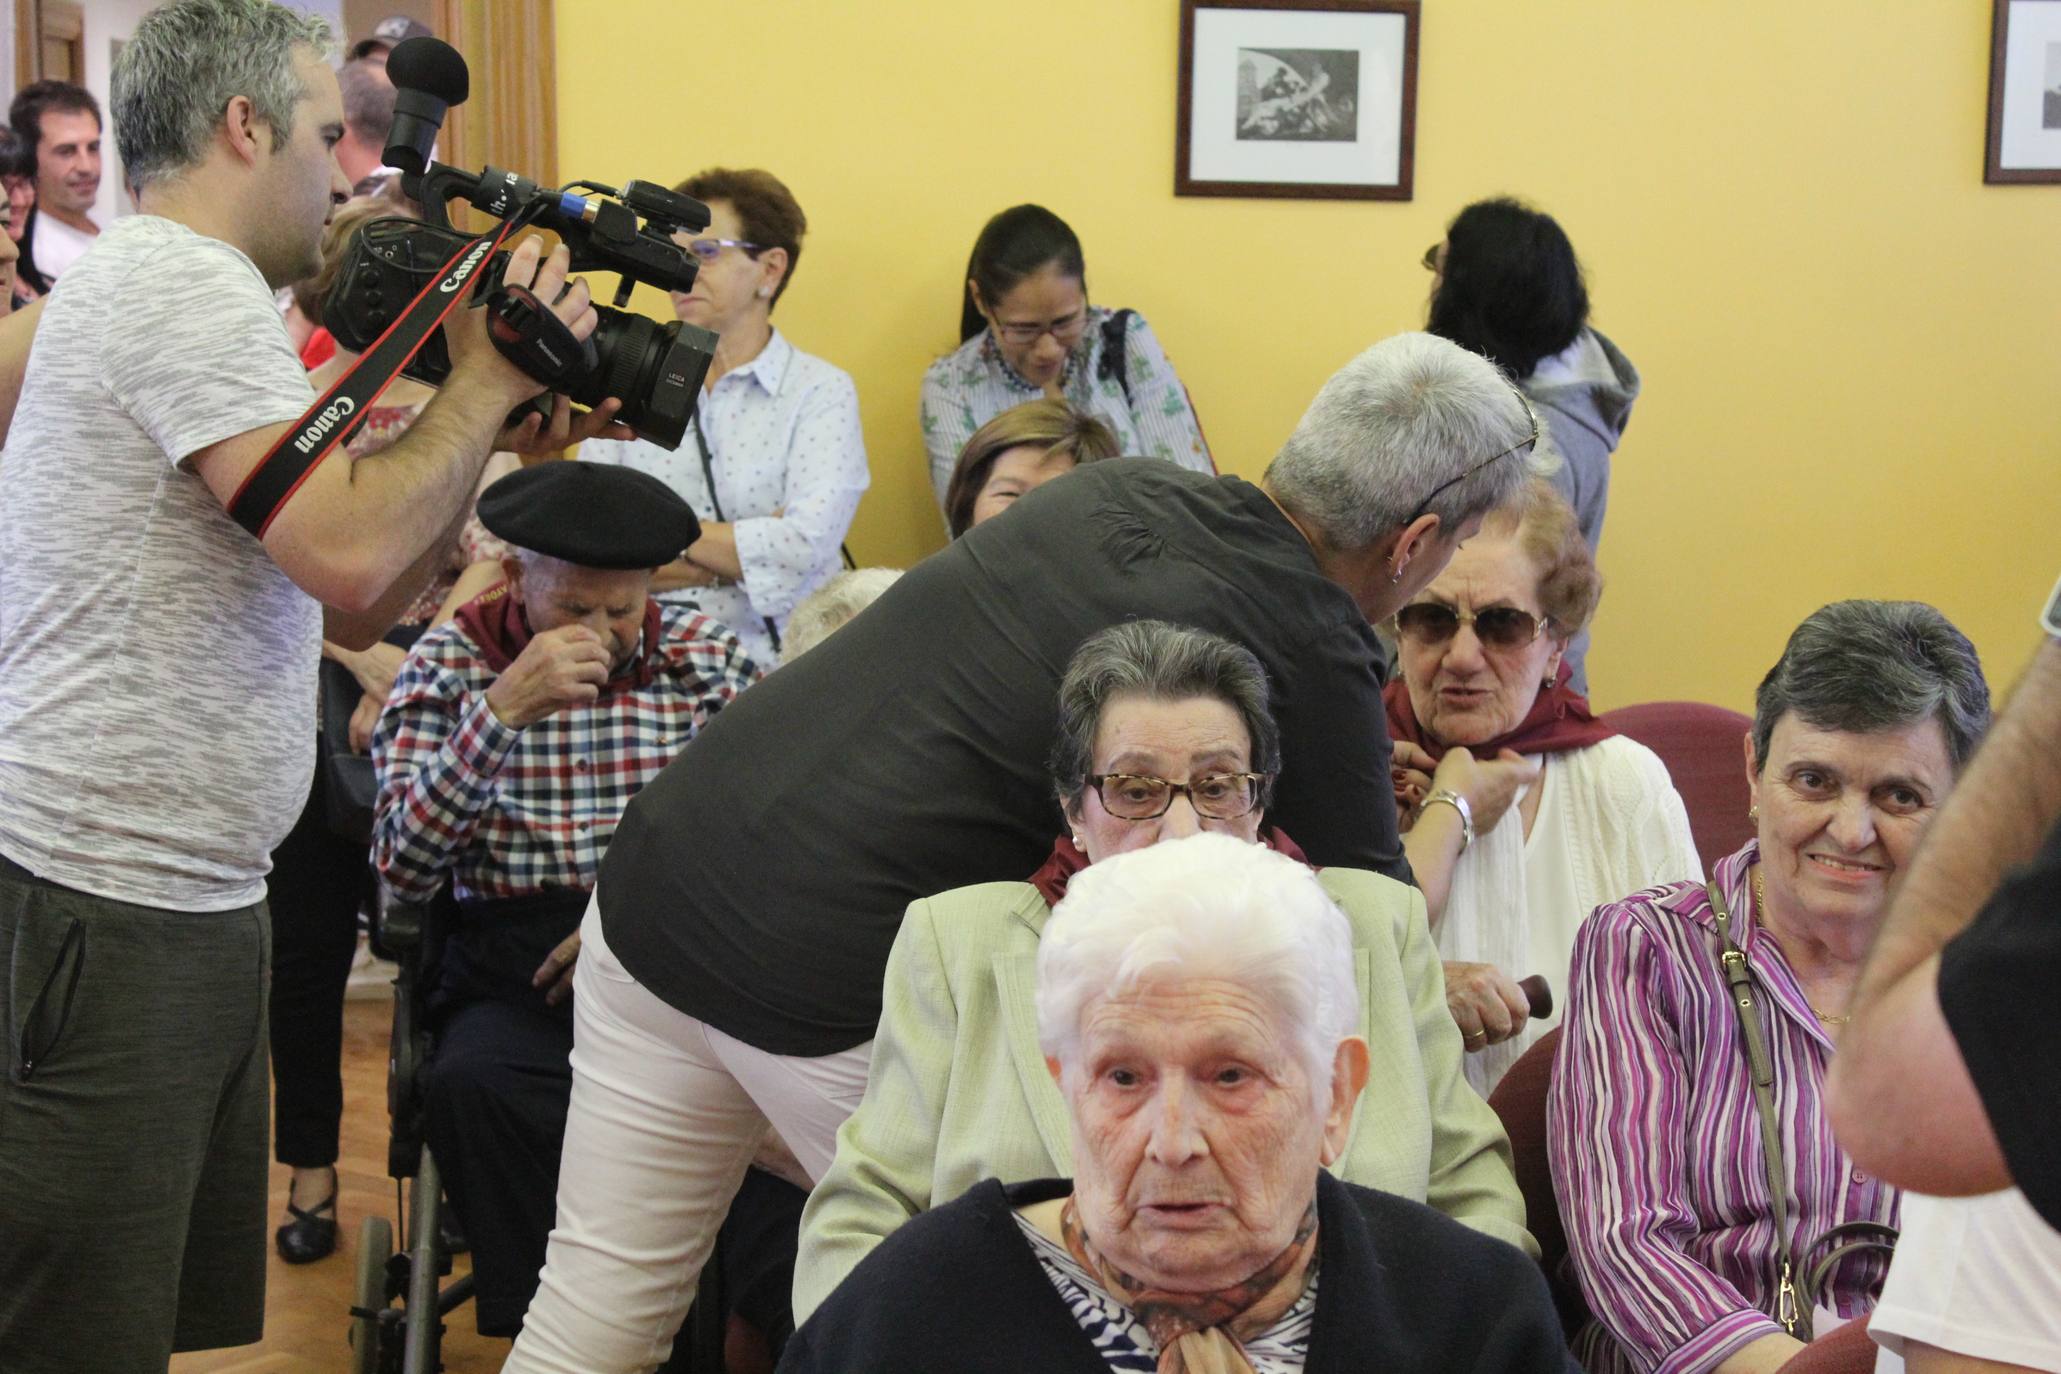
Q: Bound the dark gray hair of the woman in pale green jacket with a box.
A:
[1051,620,1282,816]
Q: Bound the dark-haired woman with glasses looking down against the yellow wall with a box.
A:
[923,206,1214,507]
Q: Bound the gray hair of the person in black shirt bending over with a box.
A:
[1265,334,1556,552]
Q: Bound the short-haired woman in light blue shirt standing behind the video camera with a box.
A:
[579,167,870,667]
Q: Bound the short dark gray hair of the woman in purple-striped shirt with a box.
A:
[1754,602,1989,772]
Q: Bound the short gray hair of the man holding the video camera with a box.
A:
[107,0,330,187]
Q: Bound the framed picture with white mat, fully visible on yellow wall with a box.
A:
[1173,0,1417,200]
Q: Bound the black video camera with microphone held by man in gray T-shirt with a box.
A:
[322,37,717,449]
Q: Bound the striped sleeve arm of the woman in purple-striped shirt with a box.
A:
[1546,902,1801,1374]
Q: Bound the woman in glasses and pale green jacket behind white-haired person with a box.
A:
[796,620,1531,1323]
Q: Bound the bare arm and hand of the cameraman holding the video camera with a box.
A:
[190,239,616,649]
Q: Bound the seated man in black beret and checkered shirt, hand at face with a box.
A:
[373,461,758,1335]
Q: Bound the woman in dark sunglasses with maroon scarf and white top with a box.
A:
[1383,478,1702,1094]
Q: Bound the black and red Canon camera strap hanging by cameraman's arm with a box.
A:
[229,220,515,540]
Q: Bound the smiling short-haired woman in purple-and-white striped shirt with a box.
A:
[1546,602,1989,1374]
